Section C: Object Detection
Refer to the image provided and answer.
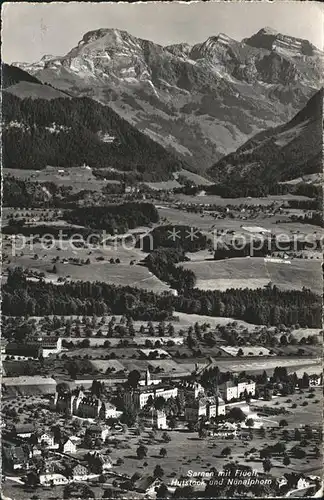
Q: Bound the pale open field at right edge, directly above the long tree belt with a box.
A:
[181,257,323,294]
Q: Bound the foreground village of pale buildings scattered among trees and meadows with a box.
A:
[2,318,323,498]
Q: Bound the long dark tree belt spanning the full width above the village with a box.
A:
[2,268,322,328]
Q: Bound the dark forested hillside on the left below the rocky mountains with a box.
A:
[2,92,185,181]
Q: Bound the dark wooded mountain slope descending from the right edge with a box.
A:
[208,89,323,184]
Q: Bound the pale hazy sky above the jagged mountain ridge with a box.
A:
[2,1,324,63]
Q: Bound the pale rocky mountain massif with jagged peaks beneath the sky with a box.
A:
[13,29,323,170]
